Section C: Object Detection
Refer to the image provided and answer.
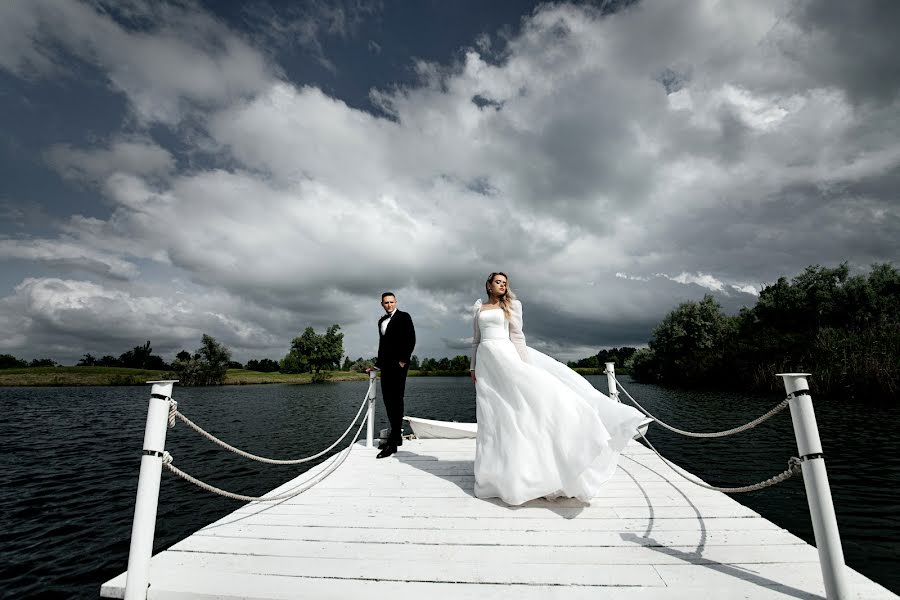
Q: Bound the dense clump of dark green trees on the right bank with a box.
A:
[630,263,900,399]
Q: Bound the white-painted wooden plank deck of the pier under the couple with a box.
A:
[101,439,898,600]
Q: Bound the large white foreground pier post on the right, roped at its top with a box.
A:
[778,373,850,600]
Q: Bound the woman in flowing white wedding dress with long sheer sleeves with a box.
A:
[470,273,644,505]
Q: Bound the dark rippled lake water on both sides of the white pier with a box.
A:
[0,377,900,598]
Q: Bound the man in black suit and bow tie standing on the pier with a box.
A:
[375,292,416,458]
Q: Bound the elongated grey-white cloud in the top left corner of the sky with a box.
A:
[0,0,274,124]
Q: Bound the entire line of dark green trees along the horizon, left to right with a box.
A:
[7,263,900,398]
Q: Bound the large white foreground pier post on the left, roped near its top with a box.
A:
[125,380,177,600]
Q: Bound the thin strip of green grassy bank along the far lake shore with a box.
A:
[0,367,602,387]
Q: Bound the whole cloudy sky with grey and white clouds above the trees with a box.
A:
[0,0,900,364]
